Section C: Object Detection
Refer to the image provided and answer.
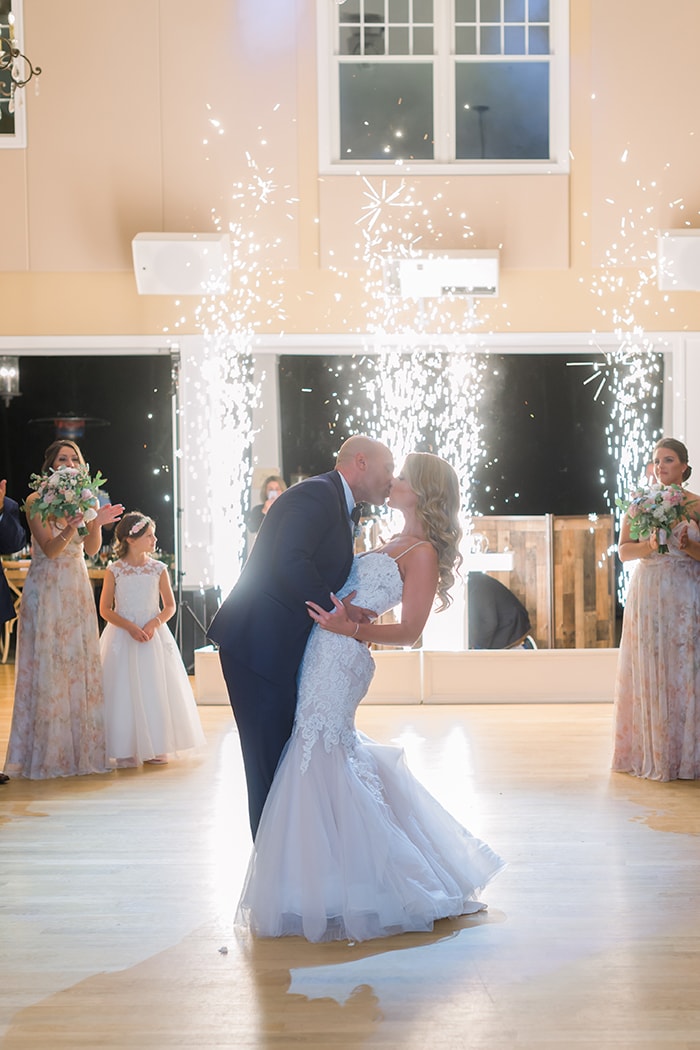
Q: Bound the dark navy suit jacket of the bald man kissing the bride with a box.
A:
[208,470,353,684]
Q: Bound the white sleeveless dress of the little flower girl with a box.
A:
[100,558,205,765]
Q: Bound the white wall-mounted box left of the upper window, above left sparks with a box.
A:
[131,233,231,295]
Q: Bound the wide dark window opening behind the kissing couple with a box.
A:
[279,345,669,515]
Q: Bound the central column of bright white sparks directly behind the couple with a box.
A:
[325,177,486,527]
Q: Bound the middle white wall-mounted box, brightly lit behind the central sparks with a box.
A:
[384,251,500,299]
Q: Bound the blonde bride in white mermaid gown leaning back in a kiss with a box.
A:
[236,453,504,941]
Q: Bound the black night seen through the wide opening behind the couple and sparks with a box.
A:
[279,353,661,515]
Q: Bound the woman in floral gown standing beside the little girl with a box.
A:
[5,440,124,780]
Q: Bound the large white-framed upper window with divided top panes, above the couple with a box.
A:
[318,0,568,173]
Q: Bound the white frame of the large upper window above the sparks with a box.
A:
[316,0,570,175]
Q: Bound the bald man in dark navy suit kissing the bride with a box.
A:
[208,435,394,838]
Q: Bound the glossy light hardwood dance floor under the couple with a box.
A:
[0,666,700,1050]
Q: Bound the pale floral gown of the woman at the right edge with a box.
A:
[613,522,700,780]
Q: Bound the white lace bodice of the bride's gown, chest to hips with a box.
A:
[294,552,403,792]
